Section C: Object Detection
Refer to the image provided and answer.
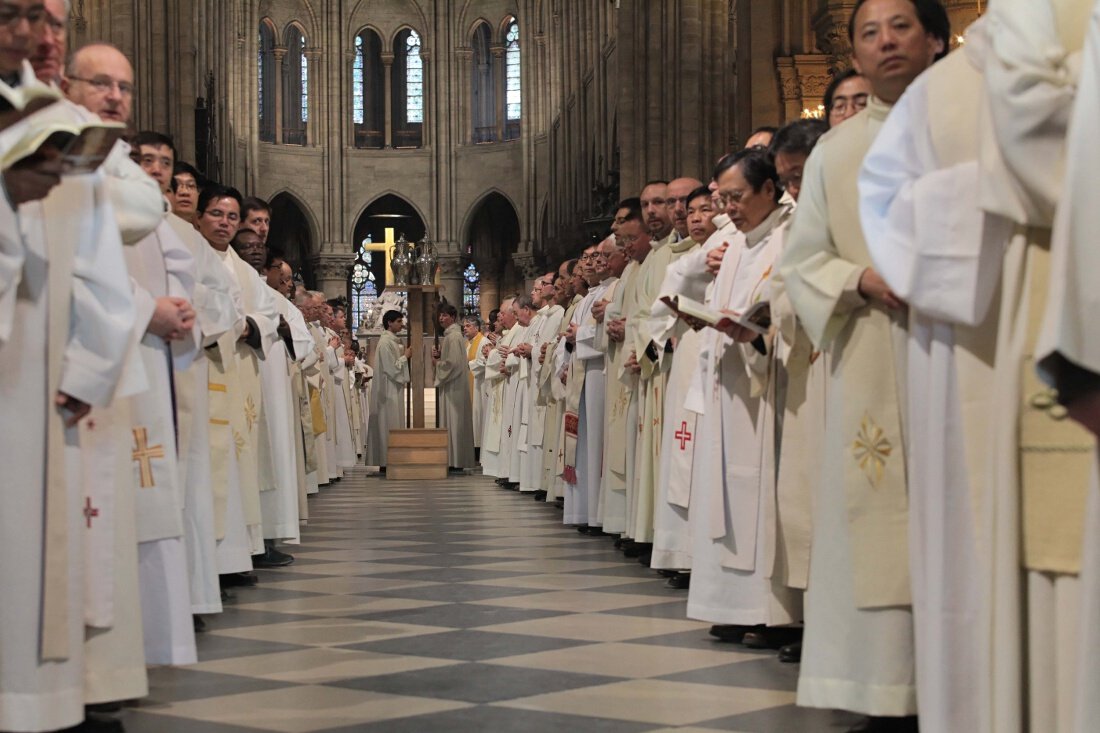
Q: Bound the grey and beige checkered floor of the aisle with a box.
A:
[123,468,853,733]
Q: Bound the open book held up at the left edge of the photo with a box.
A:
[0,121,127,175]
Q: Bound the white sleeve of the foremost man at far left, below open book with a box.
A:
[59,174,134,407]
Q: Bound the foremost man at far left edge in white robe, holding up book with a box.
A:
[0,0,141,731]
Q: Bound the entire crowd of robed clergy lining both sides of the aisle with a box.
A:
[0,0,1100,733]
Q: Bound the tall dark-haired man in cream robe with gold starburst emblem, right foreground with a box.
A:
[779,0,949,731]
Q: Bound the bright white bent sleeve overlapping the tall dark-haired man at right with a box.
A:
[859,58,1011,326]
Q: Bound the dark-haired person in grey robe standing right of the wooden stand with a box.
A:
[431,303,474,471]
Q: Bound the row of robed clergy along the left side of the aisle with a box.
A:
[0,0,371,731]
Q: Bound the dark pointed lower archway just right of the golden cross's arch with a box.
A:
[463,192,524,318]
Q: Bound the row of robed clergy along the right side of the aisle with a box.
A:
[466,0,1100,733]
